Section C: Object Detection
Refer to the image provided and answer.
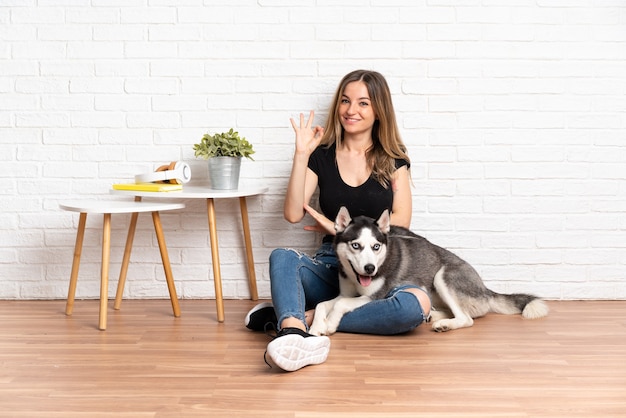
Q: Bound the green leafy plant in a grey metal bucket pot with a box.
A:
[193,128,254,190]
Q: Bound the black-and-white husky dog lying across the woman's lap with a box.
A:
[309,207,548,335]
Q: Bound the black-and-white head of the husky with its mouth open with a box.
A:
[335,207,390,287]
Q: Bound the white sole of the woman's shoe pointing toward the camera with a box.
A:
[267,334,330,372]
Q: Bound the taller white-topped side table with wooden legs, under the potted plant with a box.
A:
[111,185,268,322]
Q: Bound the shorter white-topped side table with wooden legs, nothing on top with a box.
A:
[59,200,185,330]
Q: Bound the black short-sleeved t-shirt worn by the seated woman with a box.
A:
[309,144,410,233]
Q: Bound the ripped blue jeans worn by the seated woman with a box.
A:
[269,243,426,335]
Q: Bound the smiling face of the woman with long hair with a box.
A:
[339,81,376,139]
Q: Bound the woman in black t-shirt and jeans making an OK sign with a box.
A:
[245,70,430,371]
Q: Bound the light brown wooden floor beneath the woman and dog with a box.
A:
[0,300,626,418]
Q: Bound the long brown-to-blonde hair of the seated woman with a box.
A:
[321,70,410,188]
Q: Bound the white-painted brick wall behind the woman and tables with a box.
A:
[0,0,626,299]
